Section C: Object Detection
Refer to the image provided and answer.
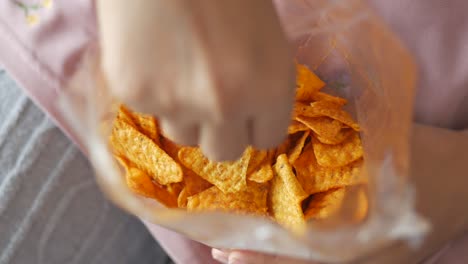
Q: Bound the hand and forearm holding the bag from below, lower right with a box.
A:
[212,125,468,264]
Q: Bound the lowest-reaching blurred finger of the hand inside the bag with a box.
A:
[199,120,249,161]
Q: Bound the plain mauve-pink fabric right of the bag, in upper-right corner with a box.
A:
[369,0,468,128]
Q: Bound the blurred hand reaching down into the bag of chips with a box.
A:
[97,0,295,160]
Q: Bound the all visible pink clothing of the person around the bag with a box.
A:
[0,0,468,263]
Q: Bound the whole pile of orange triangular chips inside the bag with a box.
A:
[110,65,368,230]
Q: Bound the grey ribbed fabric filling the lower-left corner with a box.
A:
[0,69,170,264]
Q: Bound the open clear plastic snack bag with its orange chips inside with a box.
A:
[60,0,429,262]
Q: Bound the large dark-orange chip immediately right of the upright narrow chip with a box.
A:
[294,144,367,194]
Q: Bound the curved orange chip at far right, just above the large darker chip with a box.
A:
[312,132,364,167]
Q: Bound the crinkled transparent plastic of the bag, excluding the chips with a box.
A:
[59,0,429,262]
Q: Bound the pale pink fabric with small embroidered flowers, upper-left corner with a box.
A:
[0,0,97,151]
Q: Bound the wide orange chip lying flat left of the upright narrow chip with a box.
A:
[187,182,268,215]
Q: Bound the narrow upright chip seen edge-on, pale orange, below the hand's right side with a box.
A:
[269,154,307,233]
